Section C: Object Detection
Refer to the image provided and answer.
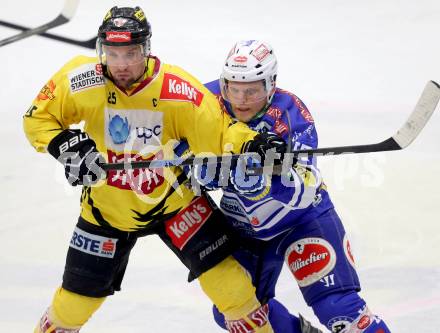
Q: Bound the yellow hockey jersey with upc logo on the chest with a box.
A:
[24,56,256,231]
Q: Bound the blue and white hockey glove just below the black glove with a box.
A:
[230,157,267,196]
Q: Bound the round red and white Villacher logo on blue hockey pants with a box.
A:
[285,238,336,287]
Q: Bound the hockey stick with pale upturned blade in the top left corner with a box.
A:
[0,0,79,46]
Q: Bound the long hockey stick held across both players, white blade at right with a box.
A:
[102,81,440,175]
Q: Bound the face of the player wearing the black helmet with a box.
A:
[104,45,145,88]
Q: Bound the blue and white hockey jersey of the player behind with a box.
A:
[205,80,333,240]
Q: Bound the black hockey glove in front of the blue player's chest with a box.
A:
[241,132,287,161]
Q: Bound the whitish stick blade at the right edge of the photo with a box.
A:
[392,81,440,149]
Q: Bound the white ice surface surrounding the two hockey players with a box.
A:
[0,0,440,333]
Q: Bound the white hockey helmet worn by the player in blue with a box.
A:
[220,40,278,104]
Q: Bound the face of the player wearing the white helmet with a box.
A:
[226,80,267,123]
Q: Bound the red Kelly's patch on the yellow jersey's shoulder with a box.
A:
[160,73,203,106]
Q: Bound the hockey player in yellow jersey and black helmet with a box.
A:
[24,7,288,333]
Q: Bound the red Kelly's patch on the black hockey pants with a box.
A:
[165,197,212,250]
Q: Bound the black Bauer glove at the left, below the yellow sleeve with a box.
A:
[47,129,106,186]
